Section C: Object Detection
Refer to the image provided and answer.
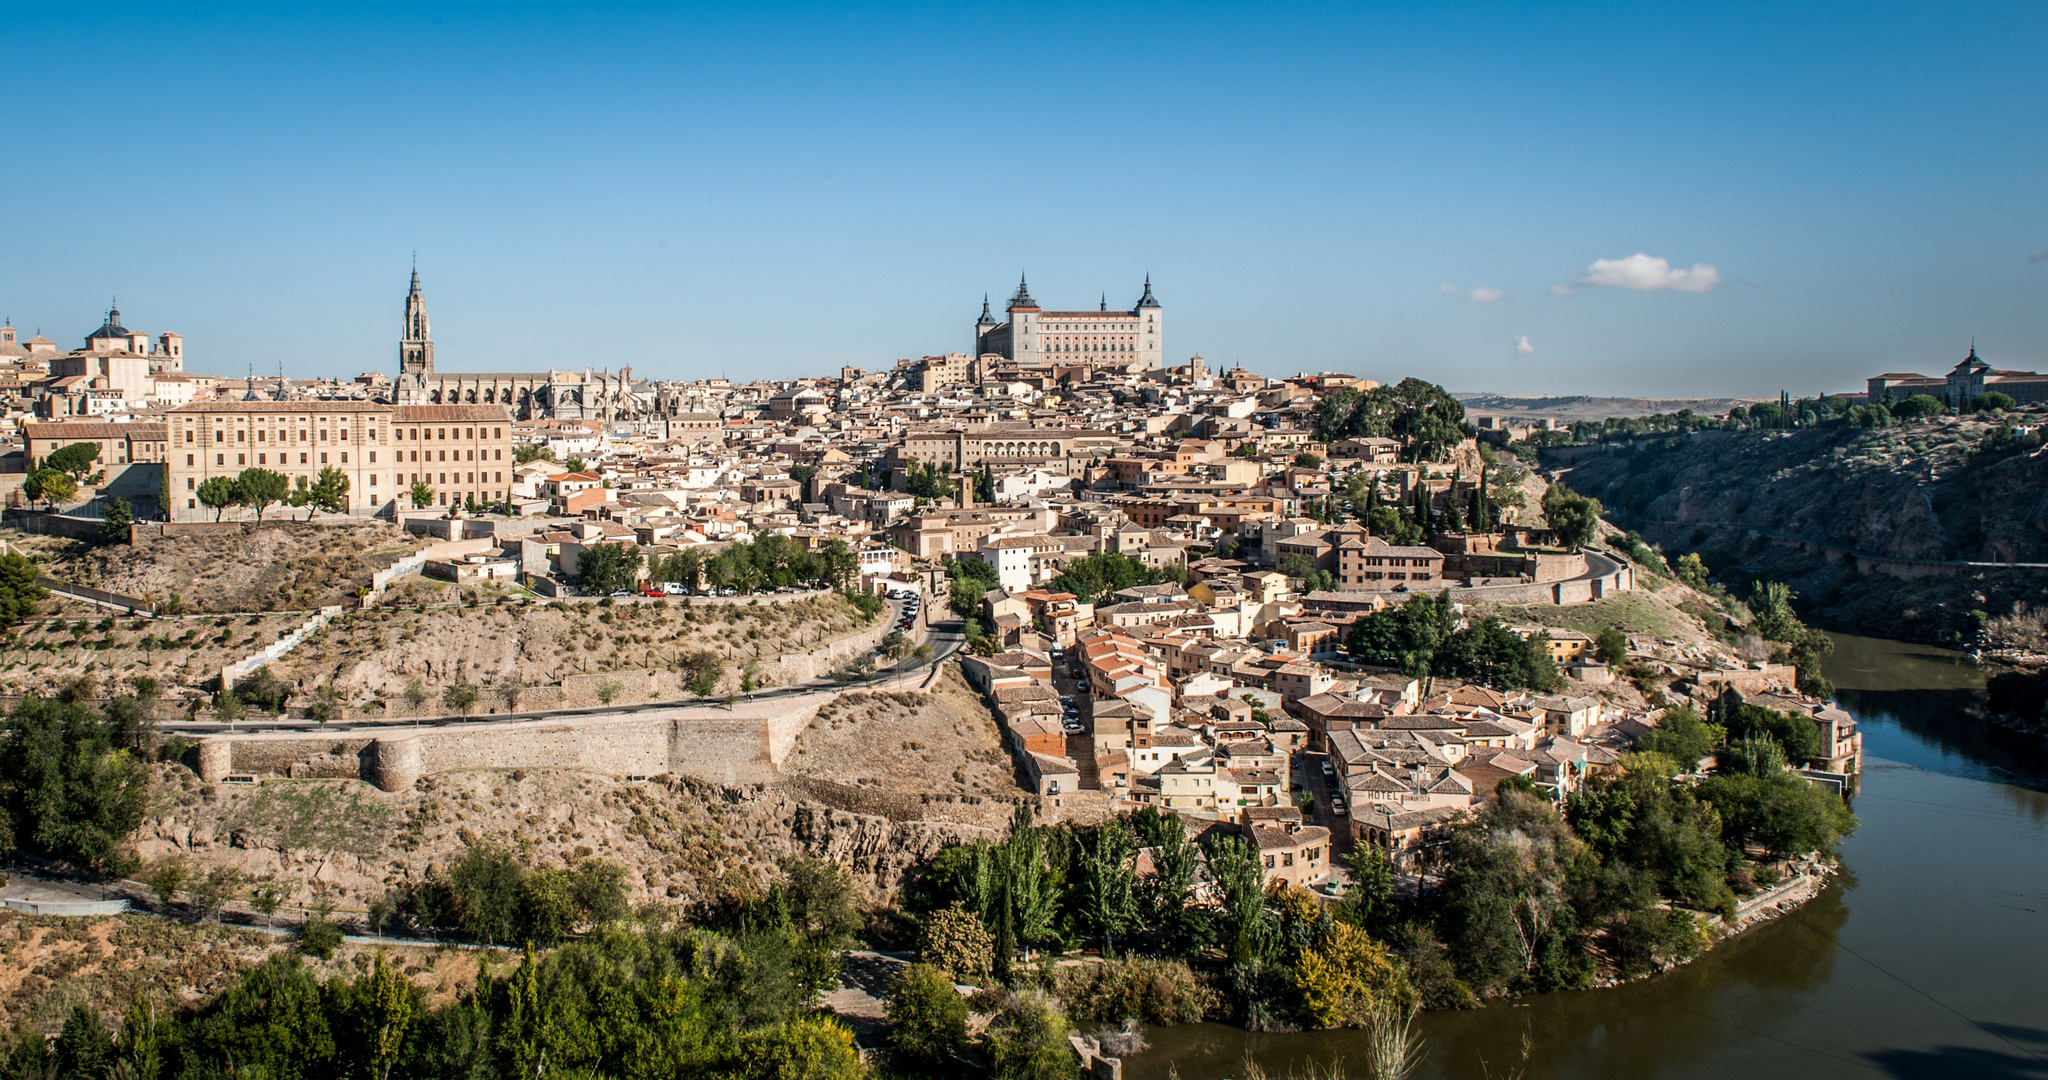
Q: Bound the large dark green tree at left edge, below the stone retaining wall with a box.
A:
[0,697,150,873]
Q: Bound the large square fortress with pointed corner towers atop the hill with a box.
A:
[973,275,1165,371]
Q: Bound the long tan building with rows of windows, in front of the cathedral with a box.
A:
[166,400,512,521]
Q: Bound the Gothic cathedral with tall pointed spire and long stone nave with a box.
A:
[391,266,655,420]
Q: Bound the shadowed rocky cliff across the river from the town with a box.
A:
[1544,414,2048,641]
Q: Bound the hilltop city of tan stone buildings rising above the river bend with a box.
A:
[12,271,1998,1076]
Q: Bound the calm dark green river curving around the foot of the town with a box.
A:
[1126,635,2048,1080]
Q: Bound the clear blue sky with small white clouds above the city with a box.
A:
[0,4,2048,396]
